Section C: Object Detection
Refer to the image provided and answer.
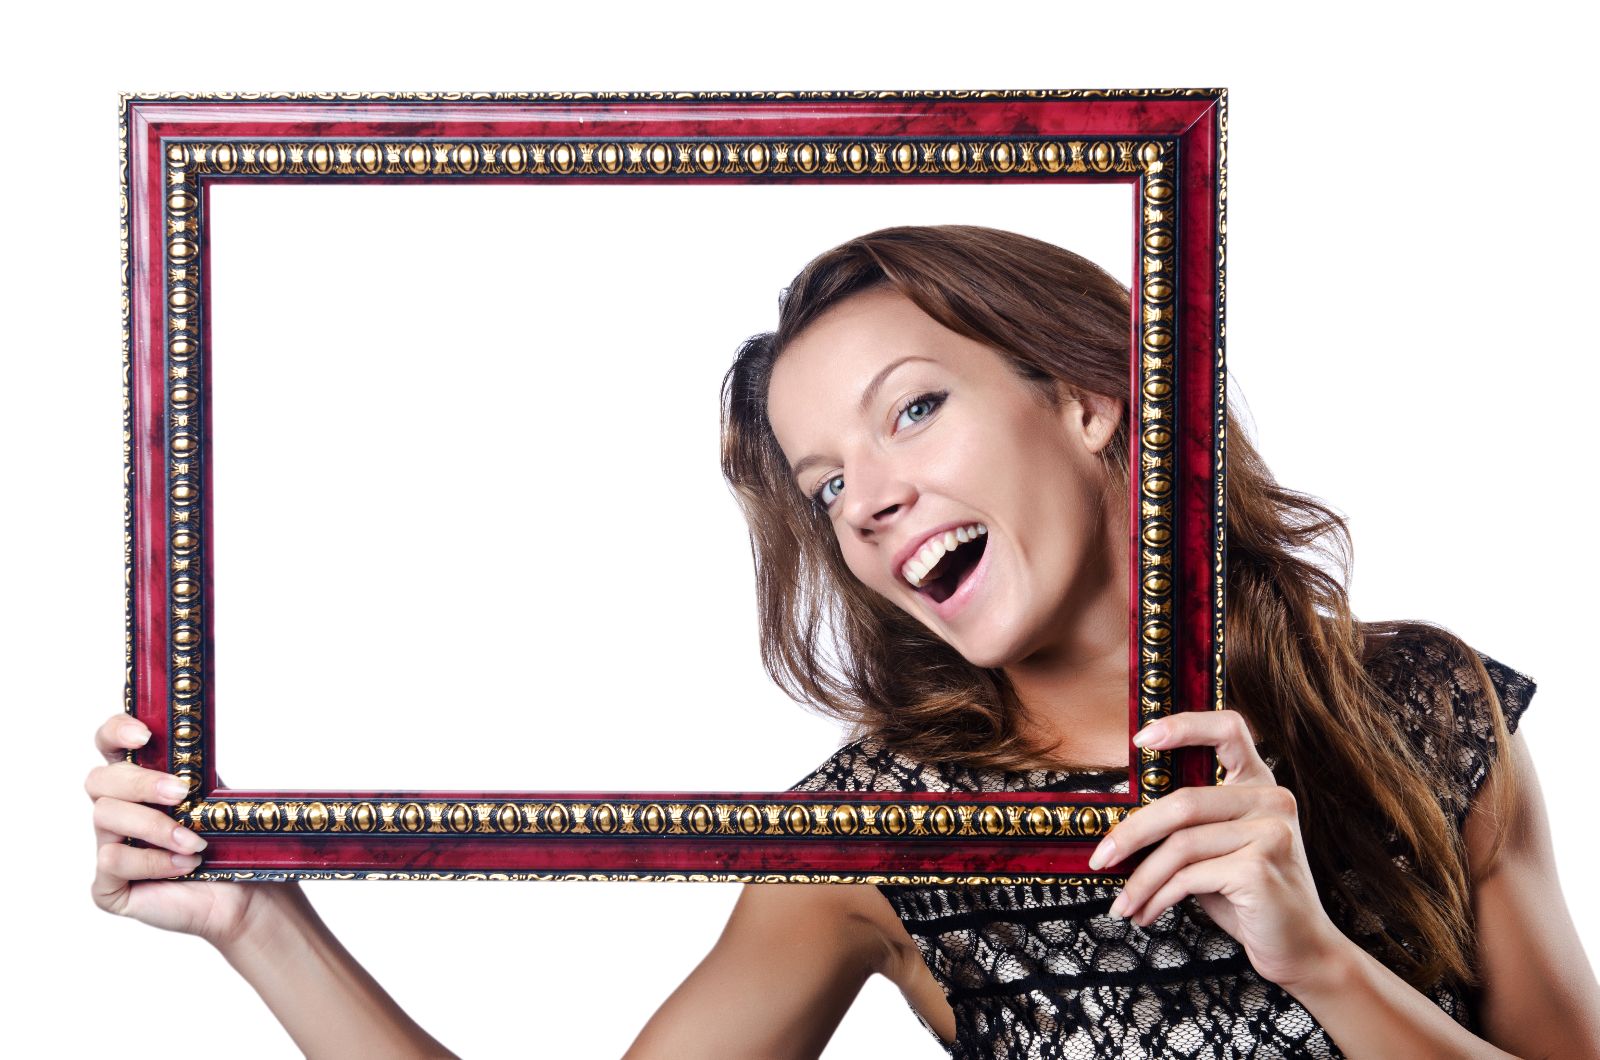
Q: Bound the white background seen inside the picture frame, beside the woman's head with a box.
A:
[206,181,1134,791]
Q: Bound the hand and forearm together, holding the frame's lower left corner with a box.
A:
[85,714,450,1057]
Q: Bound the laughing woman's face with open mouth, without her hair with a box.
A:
[768,288,1126,666]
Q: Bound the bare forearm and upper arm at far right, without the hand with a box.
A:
[1283,735,1600,1060]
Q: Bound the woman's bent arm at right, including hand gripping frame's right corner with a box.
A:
[1090,709,1600,1060]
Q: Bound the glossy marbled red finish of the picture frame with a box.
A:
[126,91,1226,874]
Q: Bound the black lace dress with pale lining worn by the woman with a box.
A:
[794,644,1534,1060]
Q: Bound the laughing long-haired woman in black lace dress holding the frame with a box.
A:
[88,226,1600,1057]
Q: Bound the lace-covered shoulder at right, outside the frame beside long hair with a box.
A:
[1366,626,1538,828]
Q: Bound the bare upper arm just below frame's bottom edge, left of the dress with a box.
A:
[624,884,896,1060]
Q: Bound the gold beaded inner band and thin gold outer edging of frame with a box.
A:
[118,90,1227,882]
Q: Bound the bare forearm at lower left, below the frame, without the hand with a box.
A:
[218,889,454,1057]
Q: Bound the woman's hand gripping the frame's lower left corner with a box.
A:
[83,713,294,946]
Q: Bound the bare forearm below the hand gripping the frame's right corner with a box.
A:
[1283,938,1512,1060]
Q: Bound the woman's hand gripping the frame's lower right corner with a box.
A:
[1090,711,1350,988]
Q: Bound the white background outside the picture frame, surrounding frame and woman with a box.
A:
[0,3,1600,1057]
